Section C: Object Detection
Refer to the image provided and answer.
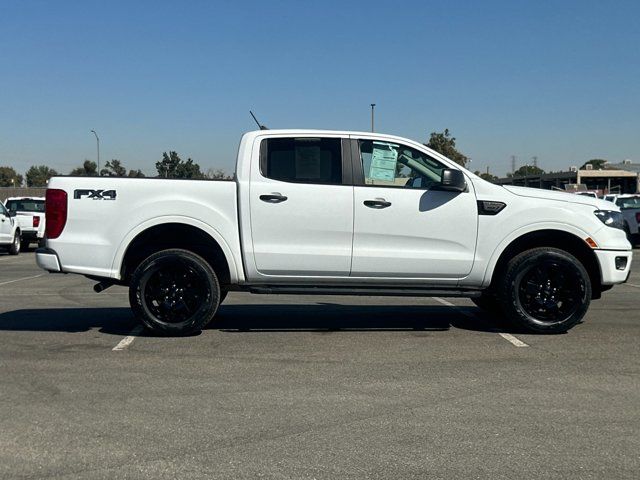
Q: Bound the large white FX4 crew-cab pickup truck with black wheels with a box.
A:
[36,130,632,335]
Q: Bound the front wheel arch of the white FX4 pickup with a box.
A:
[485,228,603,298]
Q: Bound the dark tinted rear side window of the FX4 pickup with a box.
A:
[260,138,342,185]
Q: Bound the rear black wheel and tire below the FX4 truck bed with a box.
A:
[129,249,221,336]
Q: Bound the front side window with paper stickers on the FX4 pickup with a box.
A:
[360,140,446,189]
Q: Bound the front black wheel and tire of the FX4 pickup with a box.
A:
[498,247,591,333]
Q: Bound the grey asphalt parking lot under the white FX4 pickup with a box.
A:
[0,251,640,479]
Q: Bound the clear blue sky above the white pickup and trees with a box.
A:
[0,0,640,175]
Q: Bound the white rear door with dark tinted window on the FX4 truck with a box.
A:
[249,135,353,281]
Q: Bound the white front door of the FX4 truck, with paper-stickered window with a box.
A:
[351,138,478,283]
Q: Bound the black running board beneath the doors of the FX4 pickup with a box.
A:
[247,285,482,297]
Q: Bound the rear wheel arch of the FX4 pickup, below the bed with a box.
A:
[113,218,238,285]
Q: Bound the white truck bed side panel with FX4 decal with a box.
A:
[48,177,242,279]
